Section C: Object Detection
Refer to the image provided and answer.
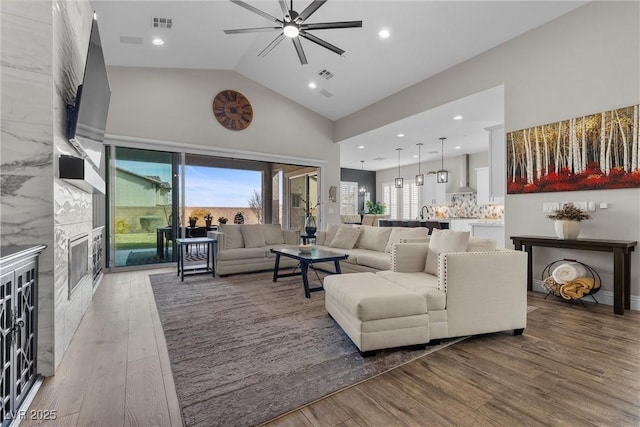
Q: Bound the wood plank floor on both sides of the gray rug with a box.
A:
[21,269,640,427]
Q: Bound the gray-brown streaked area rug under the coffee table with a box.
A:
[150,272,460,426]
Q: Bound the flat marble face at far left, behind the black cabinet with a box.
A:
[0,0,55,375]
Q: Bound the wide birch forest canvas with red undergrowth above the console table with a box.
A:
[507,105,640,194]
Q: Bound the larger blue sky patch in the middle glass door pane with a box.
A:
[185,166,262,207]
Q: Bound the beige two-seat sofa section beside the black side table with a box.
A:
[207,224,300,275]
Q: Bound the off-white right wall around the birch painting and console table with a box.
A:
[335,1,640,308]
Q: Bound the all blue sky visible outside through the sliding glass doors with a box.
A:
[116,160,262,208]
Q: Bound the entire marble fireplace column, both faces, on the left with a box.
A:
[0,0,93,375]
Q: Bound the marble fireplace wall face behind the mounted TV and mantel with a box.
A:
[53,0,93,366]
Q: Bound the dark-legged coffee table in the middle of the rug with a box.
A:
[271,248,349,298]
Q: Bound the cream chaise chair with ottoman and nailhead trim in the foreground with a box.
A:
[324,230,527,353]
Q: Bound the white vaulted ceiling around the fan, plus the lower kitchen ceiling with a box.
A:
[92,0,586,169]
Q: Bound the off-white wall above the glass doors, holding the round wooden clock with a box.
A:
[107,67,340,227]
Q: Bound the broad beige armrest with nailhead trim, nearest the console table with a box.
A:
[438,250,527,336]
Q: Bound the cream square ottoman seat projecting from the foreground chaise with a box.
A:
[324,273,430,353]
